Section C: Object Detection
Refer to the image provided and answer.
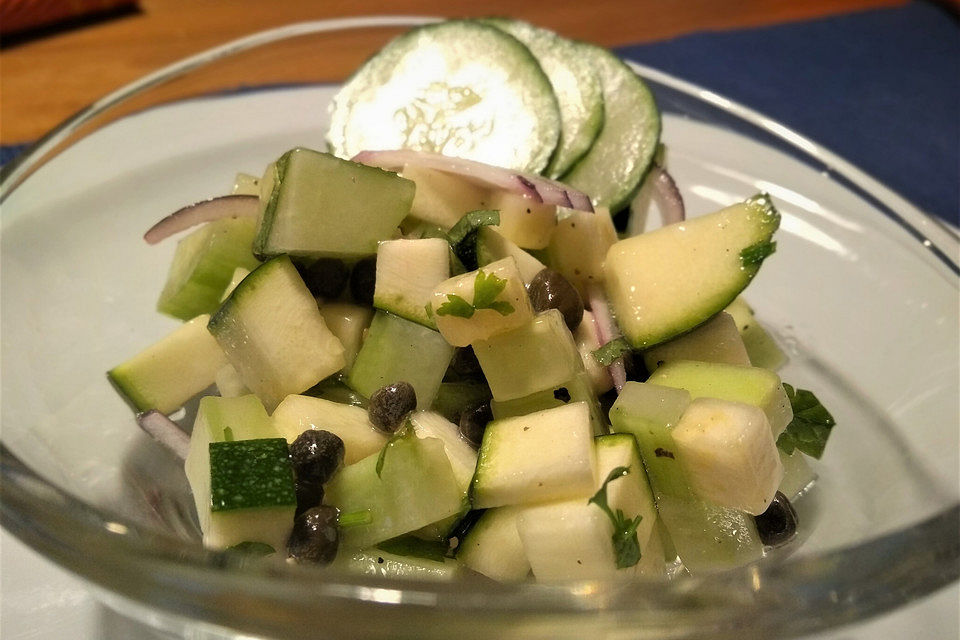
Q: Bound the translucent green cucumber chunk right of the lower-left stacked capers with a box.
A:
[324,435,463,549]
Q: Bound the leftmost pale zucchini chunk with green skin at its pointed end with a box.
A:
[107,315,227,413]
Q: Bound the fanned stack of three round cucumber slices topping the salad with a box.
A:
[328,18,660,212]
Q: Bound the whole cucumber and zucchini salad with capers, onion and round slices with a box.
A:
[108,18,834,582]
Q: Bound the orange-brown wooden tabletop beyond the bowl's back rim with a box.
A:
[0,0,904,144]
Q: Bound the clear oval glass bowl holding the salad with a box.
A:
[0,17,960,638]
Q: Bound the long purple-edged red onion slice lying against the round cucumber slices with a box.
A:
[353,149,593,213]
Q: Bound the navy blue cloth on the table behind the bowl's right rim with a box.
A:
[618,2,960,224]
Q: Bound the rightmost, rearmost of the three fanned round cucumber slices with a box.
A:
[562,44,660,213]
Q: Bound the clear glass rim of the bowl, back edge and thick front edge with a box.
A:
[0,16,960,637]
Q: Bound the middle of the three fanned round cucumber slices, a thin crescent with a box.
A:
[487,18,603,178]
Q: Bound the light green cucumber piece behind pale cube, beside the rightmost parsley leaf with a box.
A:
[647,360,793,438]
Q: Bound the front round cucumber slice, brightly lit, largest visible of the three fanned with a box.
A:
[328,20,560,172]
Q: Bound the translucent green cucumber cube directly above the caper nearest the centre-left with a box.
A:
[346,311,453,409]
